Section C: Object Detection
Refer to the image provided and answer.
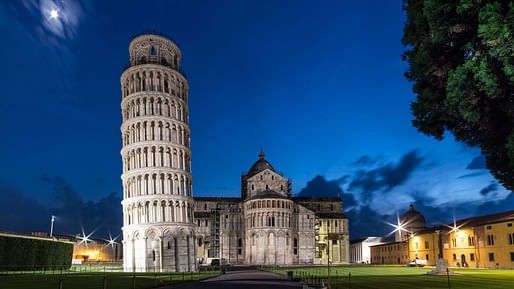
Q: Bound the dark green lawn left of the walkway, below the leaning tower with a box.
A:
[0,271,219,289]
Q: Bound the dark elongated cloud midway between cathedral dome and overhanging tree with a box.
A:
[348,150,424,199]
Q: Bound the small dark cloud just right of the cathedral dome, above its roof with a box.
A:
[298,175,357,207]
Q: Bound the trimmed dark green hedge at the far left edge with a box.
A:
[0,235,73,269]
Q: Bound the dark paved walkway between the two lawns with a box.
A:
[172,271,302,289]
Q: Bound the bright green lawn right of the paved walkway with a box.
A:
[265,265,514,289]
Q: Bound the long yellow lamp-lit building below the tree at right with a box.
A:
[408,211,514,268]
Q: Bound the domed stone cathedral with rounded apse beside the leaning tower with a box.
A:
[194,151,349,266]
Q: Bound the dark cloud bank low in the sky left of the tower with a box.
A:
[0,175,123,238]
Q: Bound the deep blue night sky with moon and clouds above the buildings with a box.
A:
[0,0,514,238]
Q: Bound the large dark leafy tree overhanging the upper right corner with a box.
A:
[402,0,514,190]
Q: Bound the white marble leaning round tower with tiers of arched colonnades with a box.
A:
[121,34,197,272]
